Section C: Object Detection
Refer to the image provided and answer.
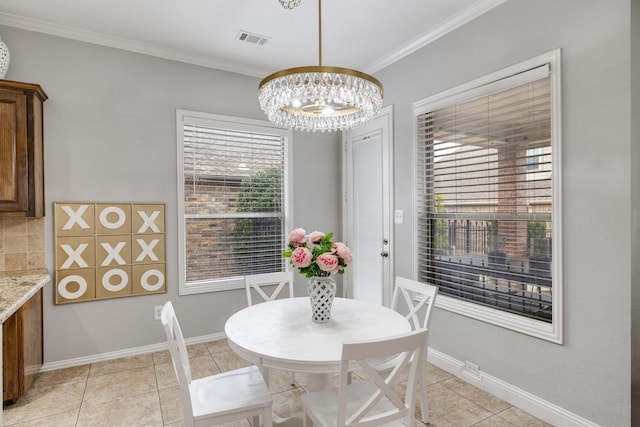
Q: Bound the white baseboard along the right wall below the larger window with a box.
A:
[427,348,600,427]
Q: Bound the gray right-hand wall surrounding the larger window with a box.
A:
[377,0,638,426]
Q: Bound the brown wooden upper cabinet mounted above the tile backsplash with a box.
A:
[0,80,47,217]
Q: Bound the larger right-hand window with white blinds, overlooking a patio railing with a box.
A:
[414,50,558,342]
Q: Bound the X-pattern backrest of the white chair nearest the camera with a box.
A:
[337,329,428,427]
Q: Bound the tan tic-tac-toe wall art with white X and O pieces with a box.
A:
[53,202,167,304]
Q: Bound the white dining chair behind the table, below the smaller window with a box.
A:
[244,271,296,385]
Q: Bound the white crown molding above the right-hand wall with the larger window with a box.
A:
[364,0,507,74]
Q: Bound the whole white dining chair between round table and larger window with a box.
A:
[384,276,438,423]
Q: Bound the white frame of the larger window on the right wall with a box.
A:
[411,49,564,344]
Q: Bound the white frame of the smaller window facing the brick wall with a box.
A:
[176,109,293,295]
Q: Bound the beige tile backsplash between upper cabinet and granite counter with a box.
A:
[0,218,46,272]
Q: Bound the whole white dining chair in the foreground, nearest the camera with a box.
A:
[302,329,428,427]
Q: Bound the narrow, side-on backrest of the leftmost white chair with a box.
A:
[160,301,193,420]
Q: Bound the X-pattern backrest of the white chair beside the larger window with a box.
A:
[391,277,438,330]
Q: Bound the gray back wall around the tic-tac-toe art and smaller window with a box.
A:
[0,27,341,362]
